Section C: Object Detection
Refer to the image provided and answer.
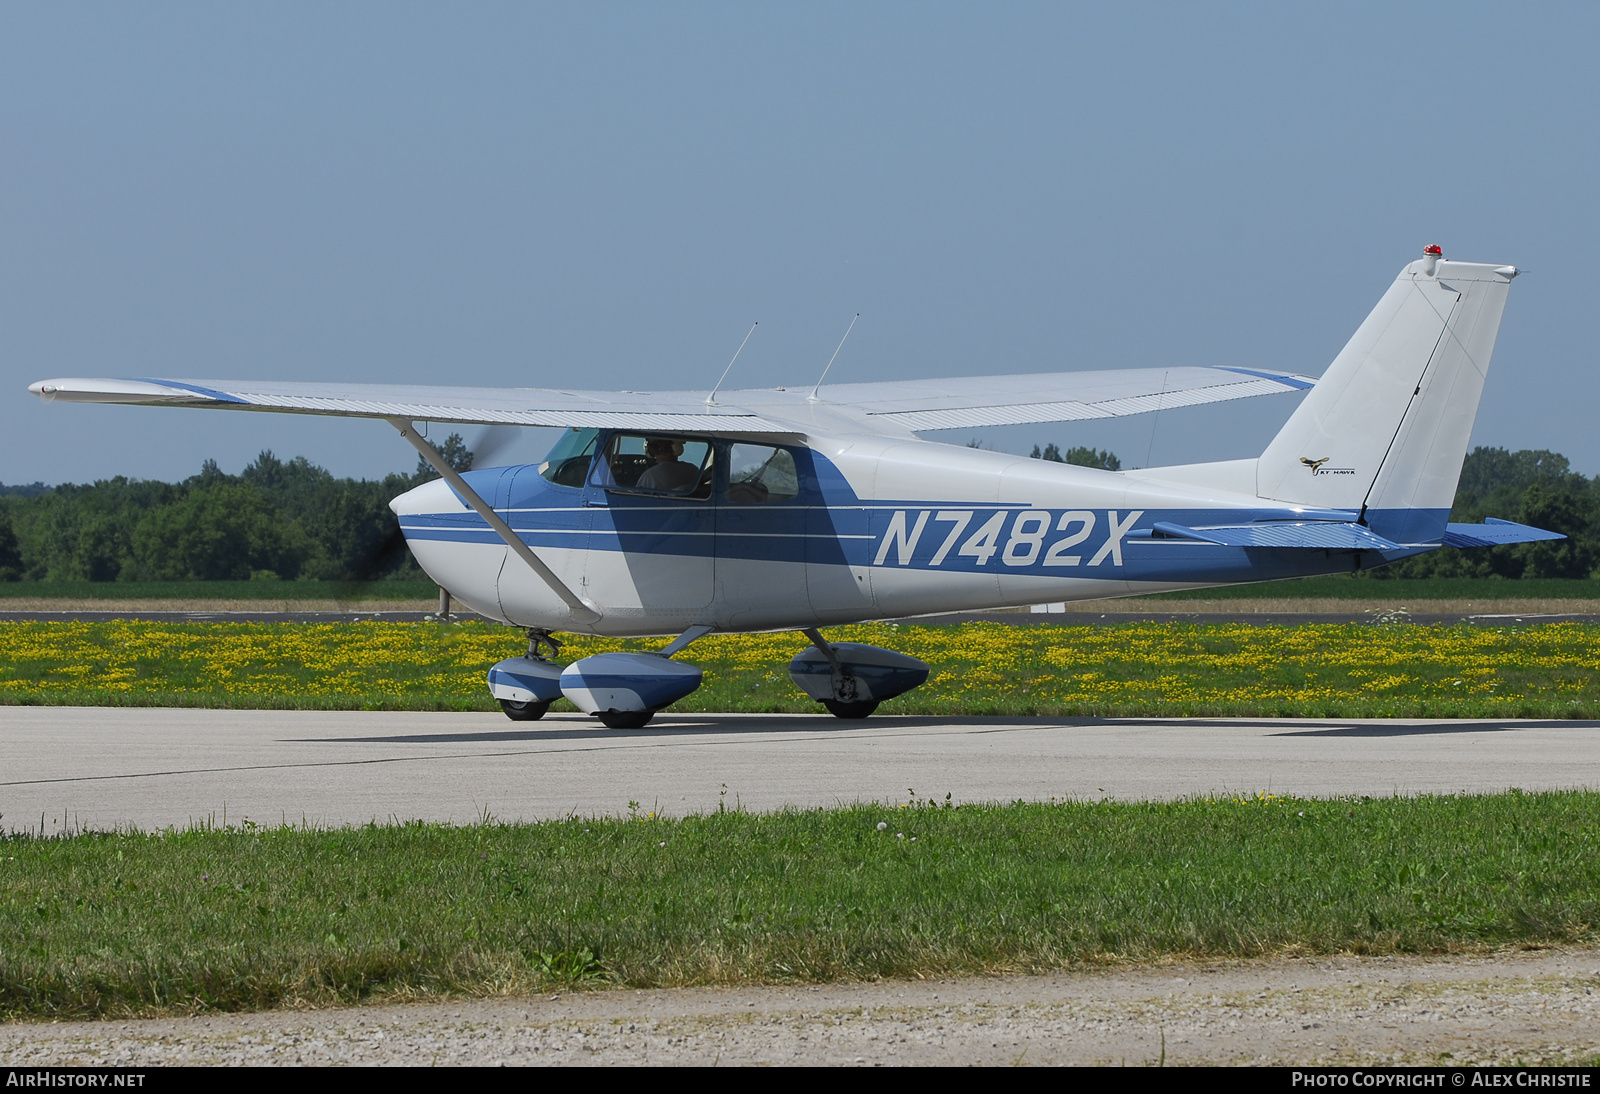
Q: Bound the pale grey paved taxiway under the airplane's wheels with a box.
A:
[0,707,1600,833]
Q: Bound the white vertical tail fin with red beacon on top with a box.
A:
[1256,248,1517,542]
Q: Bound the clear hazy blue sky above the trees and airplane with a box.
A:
[0,3,1600,483]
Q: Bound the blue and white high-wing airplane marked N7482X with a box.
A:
[29,246,1562,728]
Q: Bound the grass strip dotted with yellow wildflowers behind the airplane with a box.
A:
[0,621,1600,718]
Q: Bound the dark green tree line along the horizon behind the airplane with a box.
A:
[0,433,1600,581]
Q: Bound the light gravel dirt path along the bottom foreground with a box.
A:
[9,948,1600,1067]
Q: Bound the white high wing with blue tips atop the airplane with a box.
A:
[27,368,1315,435]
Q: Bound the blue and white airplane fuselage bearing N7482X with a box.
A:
[394,430,1446,637]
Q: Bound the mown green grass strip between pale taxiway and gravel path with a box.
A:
[0,792,1600,1020]
